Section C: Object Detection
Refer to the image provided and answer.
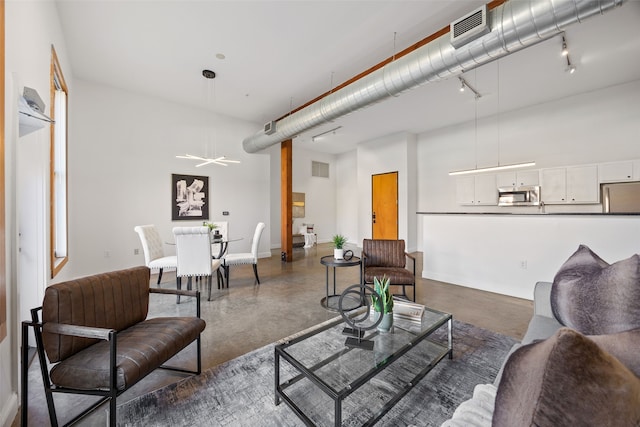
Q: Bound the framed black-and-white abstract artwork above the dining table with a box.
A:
[171,174,209,221]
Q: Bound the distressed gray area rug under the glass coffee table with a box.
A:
[118,320,517,427]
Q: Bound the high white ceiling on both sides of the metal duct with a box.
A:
[56,0,640,153]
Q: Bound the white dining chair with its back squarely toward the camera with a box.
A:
[173,226,223,302]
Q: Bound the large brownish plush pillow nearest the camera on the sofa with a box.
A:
[492,328,640,427]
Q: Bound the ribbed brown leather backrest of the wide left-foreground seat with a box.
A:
[42,267,151,363]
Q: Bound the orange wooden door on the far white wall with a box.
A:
[371,172,398,240]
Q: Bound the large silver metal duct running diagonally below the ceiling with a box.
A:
[242,0,625,153]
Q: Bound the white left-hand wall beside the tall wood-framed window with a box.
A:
[0,1,73,426]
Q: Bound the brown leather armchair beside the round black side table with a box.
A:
[362,239,416,302]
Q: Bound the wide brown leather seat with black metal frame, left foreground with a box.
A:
[21,267,205,426]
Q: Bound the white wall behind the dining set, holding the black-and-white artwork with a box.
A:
[56,80,271,281]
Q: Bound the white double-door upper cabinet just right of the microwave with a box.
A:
[540,165,600,205]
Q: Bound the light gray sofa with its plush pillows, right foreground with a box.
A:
[442,245,640,427]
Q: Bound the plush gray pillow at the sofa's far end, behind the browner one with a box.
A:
[551,245,640,335]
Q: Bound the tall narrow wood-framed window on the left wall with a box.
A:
[50,46,69,278]
